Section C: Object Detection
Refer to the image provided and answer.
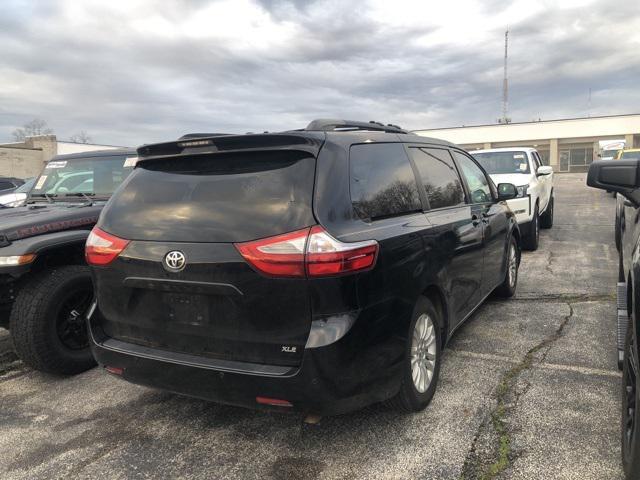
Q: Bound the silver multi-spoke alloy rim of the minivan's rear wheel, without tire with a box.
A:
[411,313,436,393]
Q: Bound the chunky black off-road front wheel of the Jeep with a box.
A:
[10,265,95,374]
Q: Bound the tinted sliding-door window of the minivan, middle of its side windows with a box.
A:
[409,147,464,209]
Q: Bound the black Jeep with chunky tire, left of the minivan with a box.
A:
[0,149,136,374]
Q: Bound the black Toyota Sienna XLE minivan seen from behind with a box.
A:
[86,120,520,414]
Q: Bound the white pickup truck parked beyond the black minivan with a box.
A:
[469,147,553,250]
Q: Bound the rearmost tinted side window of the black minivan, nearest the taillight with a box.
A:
[349,143,422,220]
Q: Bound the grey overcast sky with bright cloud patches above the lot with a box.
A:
[0,0,640,146]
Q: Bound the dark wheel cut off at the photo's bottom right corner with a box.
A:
[621,328,640,479]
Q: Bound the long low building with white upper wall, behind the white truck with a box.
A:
[414,114,640,172]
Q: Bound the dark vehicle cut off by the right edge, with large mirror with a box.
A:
[587,159,640,480]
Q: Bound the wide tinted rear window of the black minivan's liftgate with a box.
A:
[102,151,315,242]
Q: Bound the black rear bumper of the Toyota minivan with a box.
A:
[89,310,402,415]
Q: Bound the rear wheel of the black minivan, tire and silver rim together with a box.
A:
[389,297,442,412]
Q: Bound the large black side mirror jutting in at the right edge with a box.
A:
[587,159,640,207]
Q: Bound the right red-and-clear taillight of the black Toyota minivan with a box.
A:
[236,226,378,277]
